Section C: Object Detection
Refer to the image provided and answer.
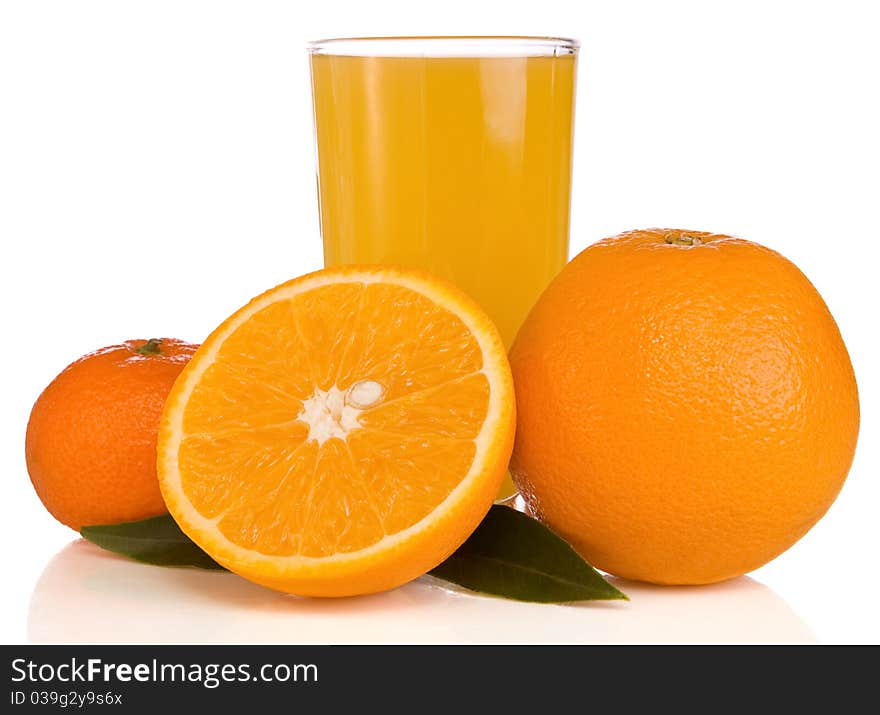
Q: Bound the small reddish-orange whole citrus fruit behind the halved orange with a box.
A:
[25,338,198,530]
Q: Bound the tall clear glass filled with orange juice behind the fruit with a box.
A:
[311,38,576,346]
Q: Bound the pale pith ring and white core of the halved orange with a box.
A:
[160,269,512,575]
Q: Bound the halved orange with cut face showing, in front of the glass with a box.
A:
[158,266,515,596]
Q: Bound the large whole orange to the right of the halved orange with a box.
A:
[510,229,859,584]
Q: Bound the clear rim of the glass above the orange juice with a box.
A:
[306,35,580,57]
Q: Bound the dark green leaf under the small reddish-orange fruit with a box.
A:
[79,514,223,569]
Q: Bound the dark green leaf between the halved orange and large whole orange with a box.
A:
[431,504,629,603]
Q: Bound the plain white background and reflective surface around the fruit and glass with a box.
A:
[0,0,880,642]
